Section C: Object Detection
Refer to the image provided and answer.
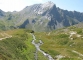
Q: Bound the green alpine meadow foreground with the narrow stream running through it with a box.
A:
[0,26,83,60]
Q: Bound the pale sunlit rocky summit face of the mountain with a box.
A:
[35,1,56,15]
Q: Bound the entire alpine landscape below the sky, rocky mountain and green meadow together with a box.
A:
[0,1,83,60]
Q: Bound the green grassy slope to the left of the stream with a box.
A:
[0,29,35,60]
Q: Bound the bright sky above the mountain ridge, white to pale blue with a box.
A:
[0,0,83,12]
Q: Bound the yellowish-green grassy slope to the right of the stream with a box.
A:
[35,27,83,60]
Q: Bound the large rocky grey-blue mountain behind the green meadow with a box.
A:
[0,1,83,31]
